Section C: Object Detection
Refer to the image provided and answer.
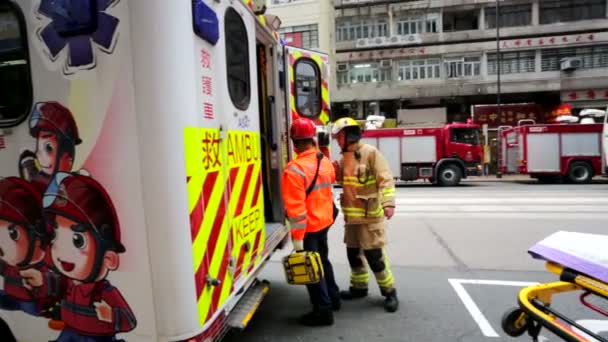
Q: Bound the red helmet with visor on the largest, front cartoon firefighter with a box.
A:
[43,172,125,253]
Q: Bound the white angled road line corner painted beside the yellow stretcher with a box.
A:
[448,279,538,337]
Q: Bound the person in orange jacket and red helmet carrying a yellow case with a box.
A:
[282,118,340,326]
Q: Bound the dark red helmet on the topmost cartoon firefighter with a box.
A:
[29,101,82,145]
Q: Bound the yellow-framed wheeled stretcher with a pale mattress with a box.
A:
[502,232,608,342]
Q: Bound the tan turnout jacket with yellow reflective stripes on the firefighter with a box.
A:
[336,143,395,224]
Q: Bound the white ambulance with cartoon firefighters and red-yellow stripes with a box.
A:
[0,0,330,342]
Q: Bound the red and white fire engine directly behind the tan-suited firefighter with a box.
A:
[332,123,483,186]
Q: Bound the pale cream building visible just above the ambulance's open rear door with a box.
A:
[267,0,334,53]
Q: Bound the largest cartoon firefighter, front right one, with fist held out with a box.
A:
[22,172,137,342]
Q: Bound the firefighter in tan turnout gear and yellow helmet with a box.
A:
[332,118,399,312]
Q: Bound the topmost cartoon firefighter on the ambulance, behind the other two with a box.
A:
[19,101,82,192]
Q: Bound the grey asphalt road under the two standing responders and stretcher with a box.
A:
[227,182,608,342]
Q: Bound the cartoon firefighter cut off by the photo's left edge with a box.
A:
[0,177,52,316]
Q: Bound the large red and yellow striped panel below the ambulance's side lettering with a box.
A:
[184,128,265,326]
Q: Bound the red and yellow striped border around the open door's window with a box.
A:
[289,50,331,125]
